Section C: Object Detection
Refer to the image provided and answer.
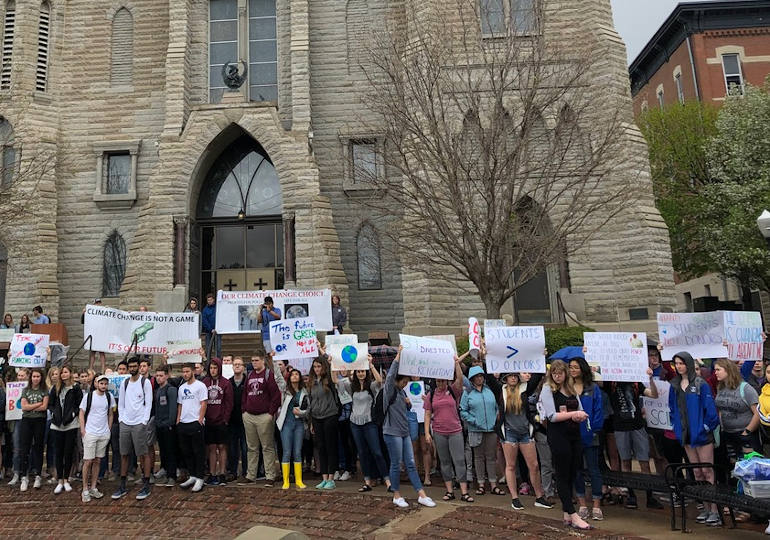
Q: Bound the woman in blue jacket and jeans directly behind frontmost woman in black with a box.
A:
[569,357,604,521]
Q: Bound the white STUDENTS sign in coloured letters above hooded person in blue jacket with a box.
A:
[658,311,727,360]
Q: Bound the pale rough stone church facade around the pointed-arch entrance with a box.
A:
[0,0,674,346]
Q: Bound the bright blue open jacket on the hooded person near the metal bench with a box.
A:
[668,377,719,446]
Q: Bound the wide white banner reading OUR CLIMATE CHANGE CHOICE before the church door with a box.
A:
[217,289,334,334]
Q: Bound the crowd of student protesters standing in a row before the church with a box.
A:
[0,298,770,529]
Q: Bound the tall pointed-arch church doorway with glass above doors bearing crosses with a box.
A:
[191,133,284,296]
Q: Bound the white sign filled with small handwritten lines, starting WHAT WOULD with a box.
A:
[583,332,650,384]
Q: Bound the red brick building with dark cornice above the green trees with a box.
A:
[629,0,770,114]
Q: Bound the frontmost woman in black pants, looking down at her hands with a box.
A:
[540,360,593,530]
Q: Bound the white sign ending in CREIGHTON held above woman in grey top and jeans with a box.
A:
[398,334,455,380]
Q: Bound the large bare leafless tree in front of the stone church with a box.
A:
[349,0,630,318]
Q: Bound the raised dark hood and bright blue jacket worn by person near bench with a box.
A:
[668,352,719,446]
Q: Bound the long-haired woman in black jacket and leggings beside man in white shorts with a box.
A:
[48,365,83,495]
